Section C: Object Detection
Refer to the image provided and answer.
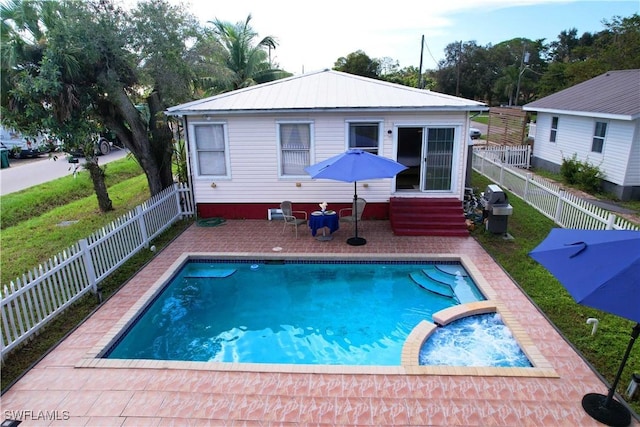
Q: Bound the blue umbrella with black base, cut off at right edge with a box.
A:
[529,228,640,426]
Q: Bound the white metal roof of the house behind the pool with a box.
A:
[167,70,487,115]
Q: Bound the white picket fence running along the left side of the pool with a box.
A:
[0,184,195,362]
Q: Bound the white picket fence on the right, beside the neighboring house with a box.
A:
[471,147,640,234]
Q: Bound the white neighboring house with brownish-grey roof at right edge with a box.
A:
[523,70,640,200]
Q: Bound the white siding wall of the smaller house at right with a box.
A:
[533,113,639,184]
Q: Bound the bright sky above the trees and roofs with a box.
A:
[178,0,640,74]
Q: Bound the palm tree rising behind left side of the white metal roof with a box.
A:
[209,15,291,90]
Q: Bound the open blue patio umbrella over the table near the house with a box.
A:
[304,149,407,246]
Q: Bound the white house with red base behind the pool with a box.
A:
[167,70,487,237]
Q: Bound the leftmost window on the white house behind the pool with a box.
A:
[193,123,229,177]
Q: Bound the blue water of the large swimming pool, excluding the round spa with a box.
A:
[104,261,484,365]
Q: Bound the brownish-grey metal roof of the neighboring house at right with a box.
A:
[523,69,640,120]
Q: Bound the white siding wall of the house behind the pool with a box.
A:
[189,112,467,203]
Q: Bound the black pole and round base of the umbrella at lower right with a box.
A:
[582,323,640,426]
